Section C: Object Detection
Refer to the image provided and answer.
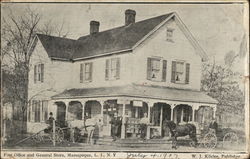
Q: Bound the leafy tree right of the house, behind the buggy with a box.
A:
[201,63,244,117]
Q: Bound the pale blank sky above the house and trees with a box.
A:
[2,3,248,72]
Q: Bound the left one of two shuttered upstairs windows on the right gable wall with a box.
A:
[147,58,167,81]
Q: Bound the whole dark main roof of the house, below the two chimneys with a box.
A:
[37,13,205,60]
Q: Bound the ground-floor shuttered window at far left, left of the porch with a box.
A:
[28,100,48,122]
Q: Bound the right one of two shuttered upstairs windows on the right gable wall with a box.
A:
[171,61,190,84]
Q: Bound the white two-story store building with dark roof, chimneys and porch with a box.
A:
[27,10,217,138]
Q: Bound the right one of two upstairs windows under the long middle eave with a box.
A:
[105,58,120,80]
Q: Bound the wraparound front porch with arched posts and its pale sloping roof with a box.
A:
[49,85,217,139]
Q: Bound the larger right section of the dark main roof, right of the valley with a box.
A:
[74,13,172,58]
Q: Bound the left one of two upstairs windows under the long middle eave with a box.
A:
[80,62,93,83]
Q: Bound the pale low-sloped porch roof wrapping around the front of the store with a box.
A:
[52,84,218,104]
